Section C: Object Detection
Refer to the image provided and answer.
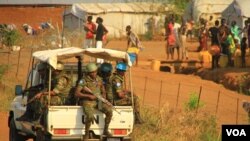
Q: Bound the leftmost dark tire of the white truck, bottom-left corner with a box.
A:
[9,118,26,141]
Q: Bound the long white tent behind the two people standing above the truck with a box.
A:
[64,3,169,38]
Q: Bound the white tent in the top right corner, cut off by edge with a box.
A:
[222,0,250,28]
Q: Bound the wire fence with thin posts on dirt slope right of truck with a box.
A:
[133,77,248,124]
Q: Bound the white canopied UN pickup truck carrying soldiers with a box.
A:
[8,47,134,141]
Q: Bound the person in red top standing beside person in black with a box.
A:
[83,16,96,49]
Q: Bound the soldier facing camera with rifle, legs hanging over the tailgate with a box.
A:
[75,63,113,140]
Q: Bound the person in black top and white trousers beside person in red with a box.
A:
[95,17,108,64]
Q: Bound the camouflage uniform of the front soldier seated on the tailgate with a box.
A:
[78,76,113,133]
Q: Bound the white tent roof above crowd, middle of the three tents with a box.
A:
[185,0,233,21]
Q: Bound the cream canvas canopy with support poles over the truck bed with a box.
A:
[32,47,134,107]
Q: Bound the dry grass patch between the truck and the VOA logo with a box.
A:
[132,99,220,141]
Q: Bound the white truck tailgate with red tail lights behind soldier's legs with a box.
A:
[47,106,134,137]
